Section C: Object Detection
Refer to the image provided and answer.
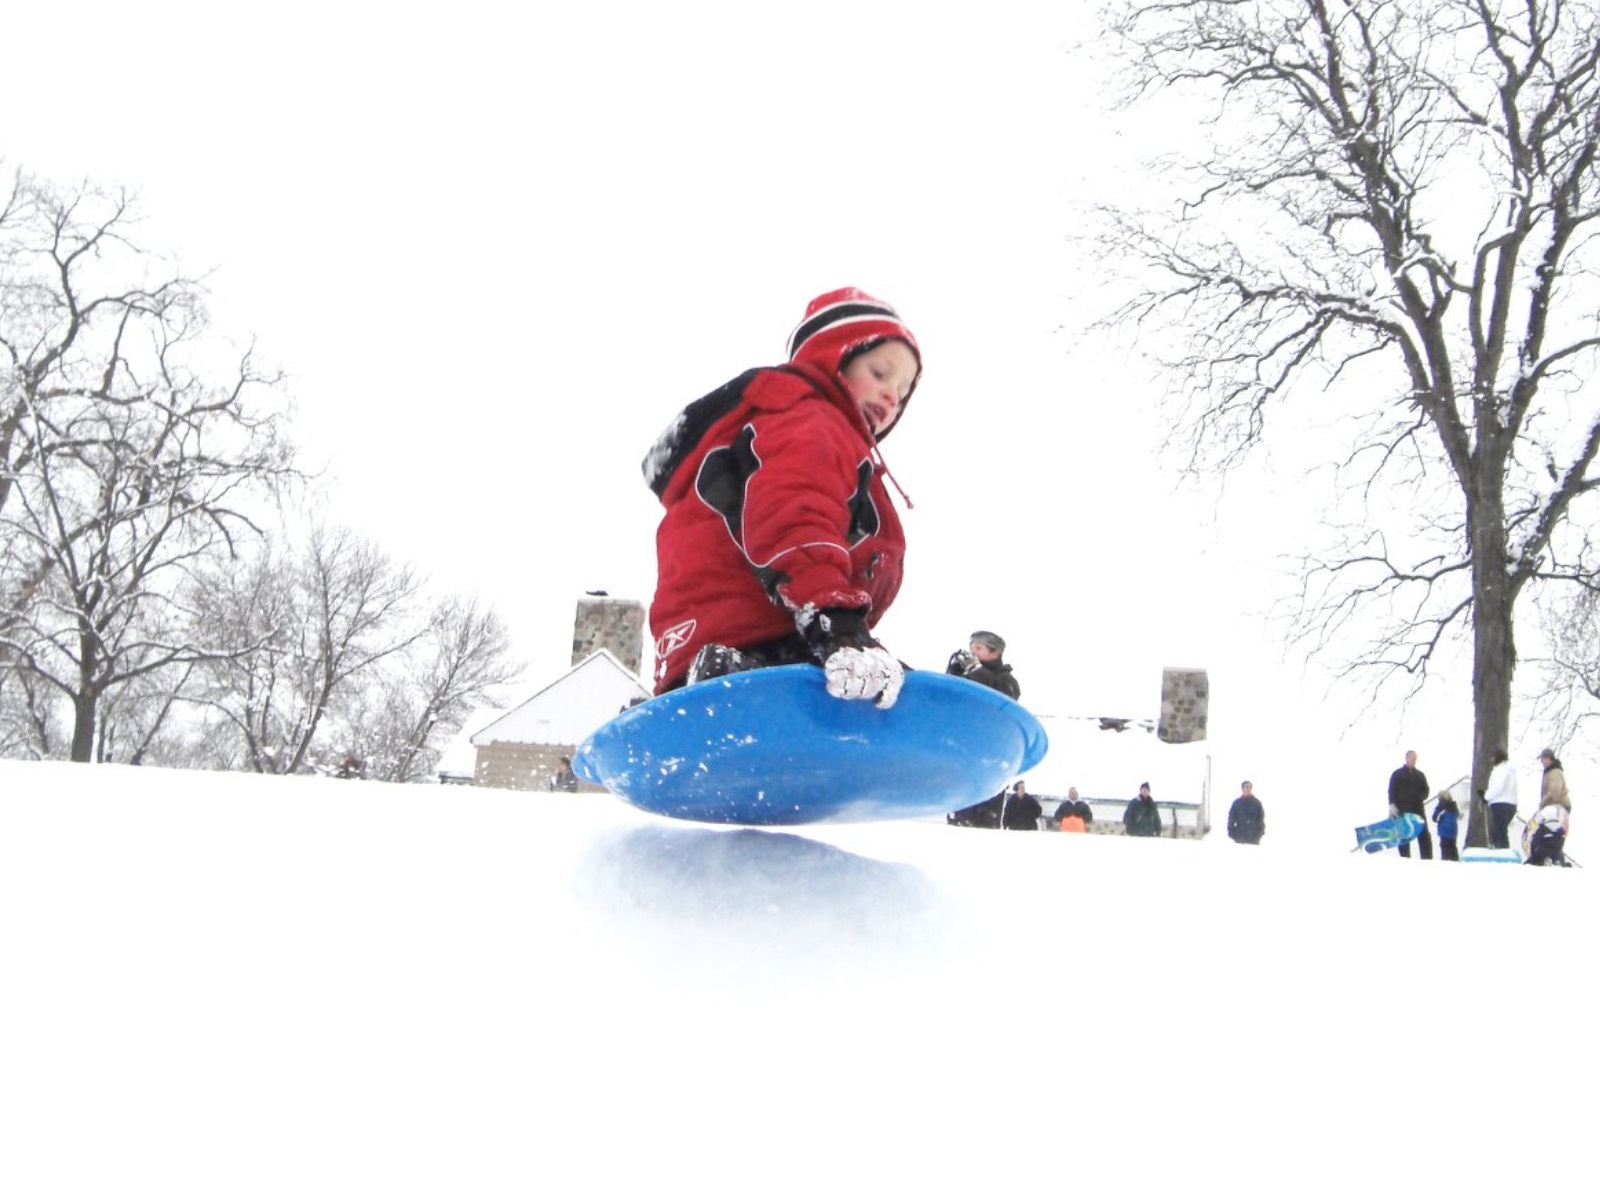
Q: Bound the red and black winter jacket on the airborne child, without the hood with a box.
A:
[645,363,906,693]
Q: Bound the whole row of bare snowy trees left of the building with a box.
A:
[0,170,520,781]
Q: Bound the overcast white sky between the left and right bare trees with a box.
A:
[9,0,1539,825]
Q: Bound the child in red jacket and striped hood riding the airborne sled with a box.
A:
[643,288,922,709]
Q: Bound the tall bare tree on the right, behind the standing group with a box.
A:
[1107,0,1600,845]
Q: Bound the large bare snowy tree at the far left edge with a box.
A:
[0,176,291,762]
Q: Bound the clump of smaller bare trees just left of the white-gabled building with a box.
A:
[188,530,522,782]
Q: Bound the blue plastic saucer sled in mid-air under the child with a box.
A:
[573,666,1050,826]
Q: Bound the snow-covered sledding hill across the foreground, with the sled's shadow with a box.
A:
[0,762,1600,1200]
